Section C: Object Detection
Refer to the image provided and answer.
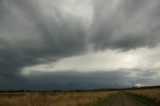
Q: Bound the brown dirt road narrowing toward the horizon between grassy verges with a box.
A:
[110,92,144,106]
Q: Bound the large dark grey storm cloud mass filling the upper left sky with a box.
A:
[0,0,85,77]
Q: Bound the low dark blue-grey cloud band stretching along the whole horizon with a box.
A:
[0,69,159,90]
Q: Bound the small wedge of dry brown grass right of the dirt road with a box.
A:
[128,88,160,101]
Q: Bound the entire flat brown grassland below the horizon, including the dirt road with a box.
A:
[0,88,160,106]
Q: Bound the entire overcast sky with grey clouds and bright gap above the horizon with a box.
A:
[0,0,160,90]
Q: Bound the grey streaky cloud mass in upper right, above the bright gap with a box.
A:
[91,0,160,50]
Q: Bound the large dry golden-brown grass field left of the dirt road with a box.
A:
[0,92,114,106]
